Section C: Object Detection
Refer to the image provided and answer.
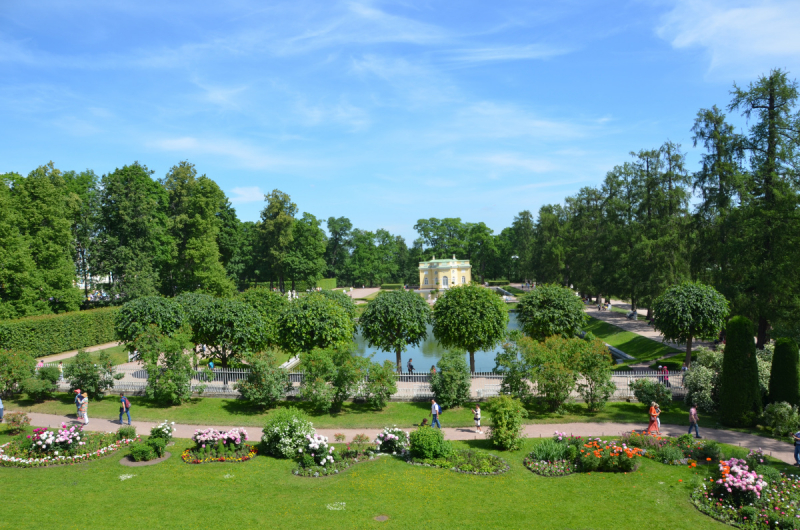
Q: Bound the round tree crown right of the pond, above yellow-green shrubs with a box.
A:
[517,284,586,340]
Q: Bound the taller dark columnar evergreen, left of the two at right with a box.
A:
[719,316,761,427]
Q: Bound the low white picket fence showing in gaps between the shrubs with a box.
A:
[45,363,686,401]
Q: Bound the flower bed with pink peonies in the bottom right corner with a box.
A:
[691,458,800,529]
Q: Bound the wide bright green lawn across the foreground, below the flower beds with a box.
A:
[0,420,752,530]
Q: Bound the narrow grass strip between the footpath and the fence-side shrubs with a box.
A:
[4,394,716,429]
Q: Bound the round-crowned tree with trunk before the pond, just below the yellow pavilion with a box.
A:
[433,285,508,372]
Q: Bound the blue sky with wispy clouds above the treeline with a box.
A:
[0,0,800,242]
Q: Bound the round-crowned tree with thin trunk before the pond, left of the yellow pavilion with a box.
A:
[359,290,431,373]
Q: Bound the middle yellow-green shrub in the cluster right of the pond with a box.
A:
[518,336,580,411]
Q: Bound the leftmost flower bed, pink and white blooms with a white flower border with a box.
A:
[0,423,138,467]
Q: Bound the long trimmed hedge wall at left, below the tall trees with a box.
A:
[0,307,120,357]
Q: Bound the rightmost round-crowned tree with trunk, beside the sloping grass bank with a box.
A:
[652,282,728,366]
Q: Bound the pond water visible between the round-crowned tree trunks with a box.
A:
[355,312,519,372]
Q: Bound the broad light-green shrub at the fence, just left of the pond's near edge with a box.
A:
[300,348,370,412]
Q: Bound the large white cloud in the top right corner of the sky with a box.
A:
[656,0,800,76]
